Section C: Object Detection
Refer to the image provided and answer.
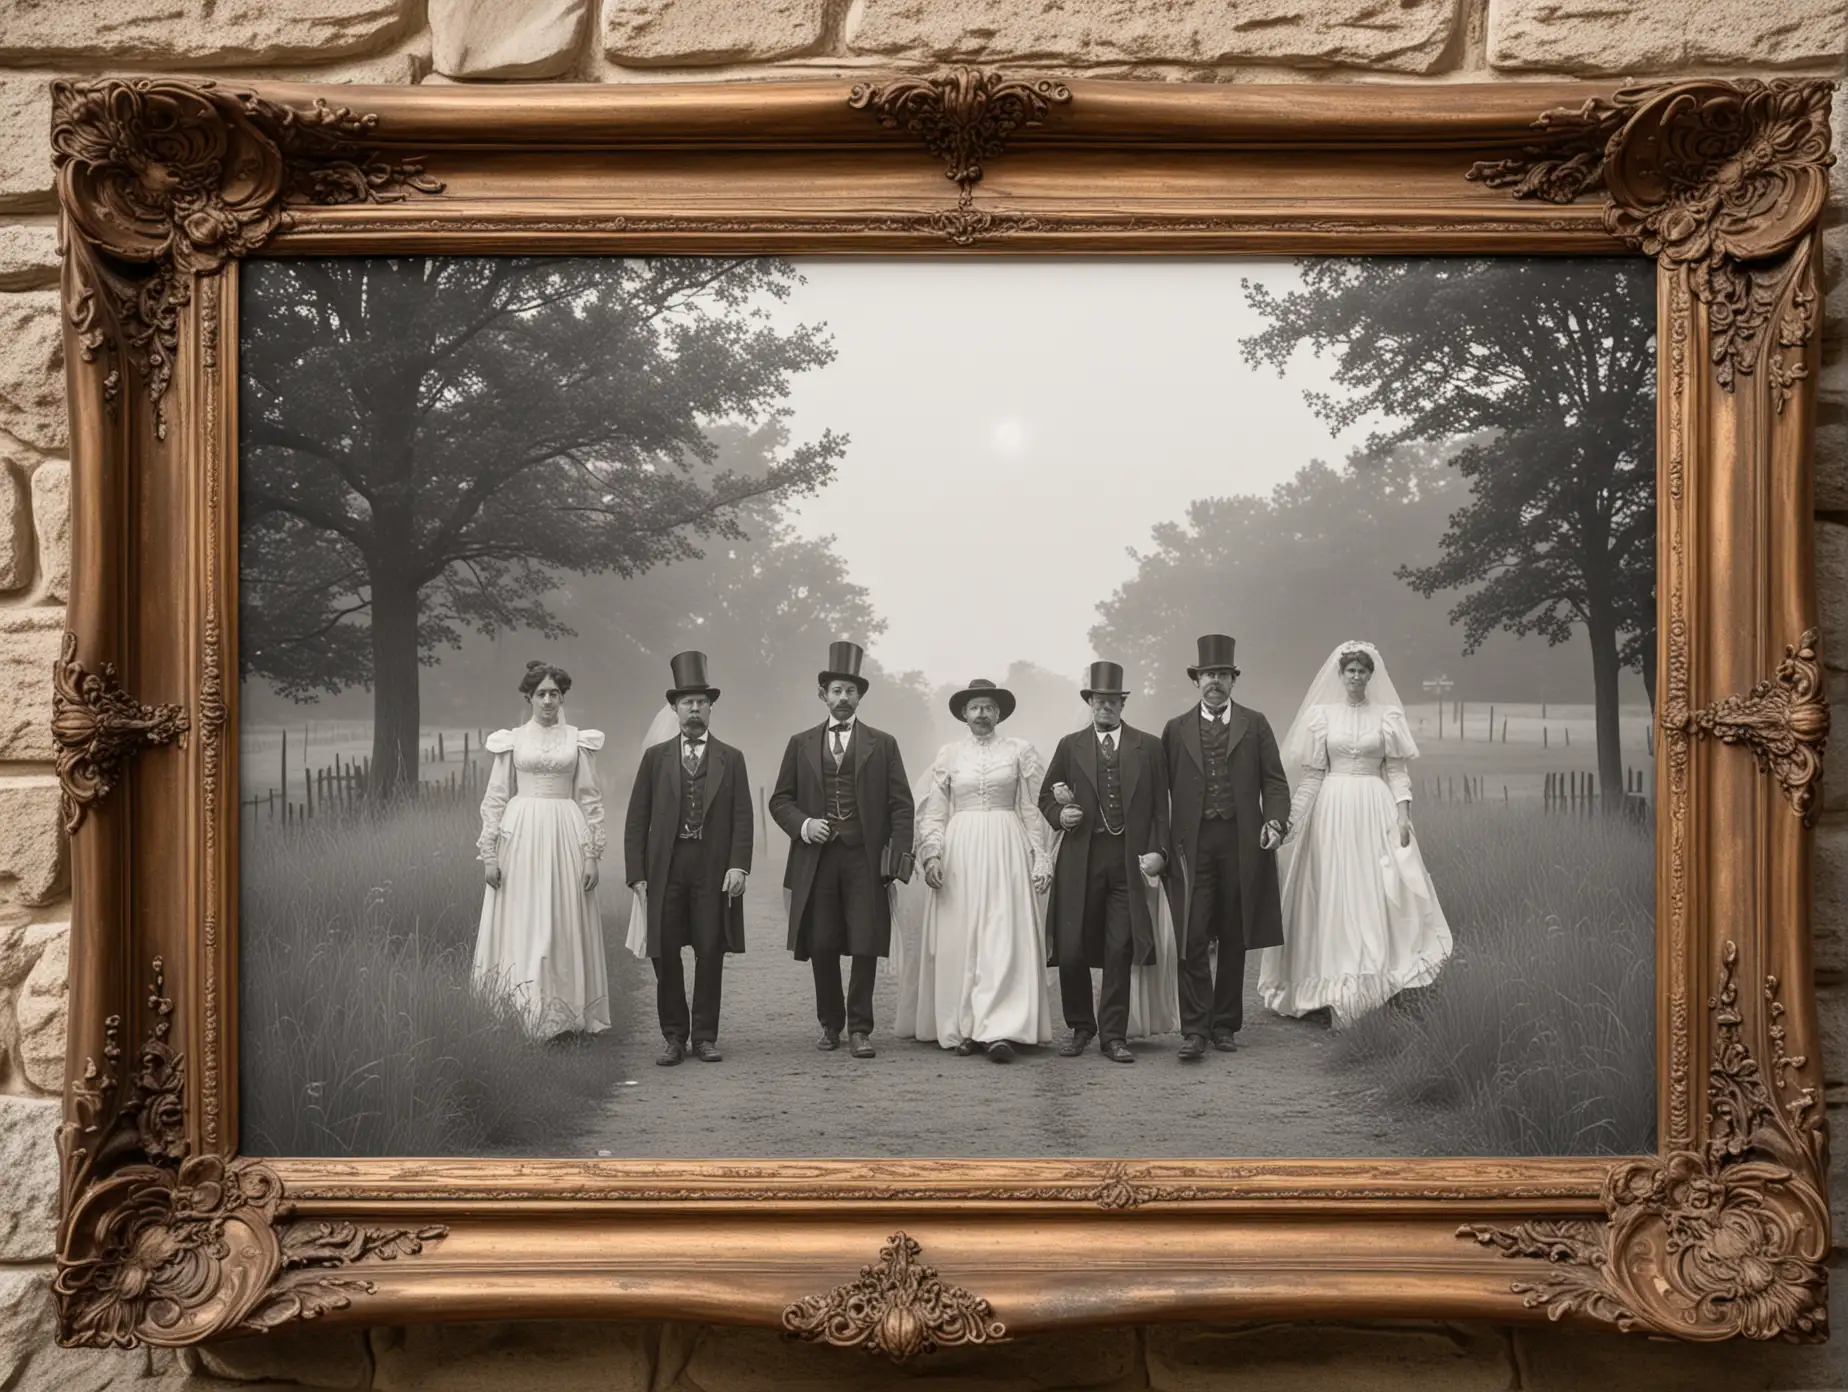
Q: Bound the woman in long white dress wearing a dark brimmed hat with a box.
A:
[917,680,1052,1063]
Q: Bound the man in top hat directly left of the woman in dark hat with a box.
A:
[771,643,911,1059]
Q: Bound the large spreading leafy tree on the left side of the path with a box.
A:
[238,257,845,795]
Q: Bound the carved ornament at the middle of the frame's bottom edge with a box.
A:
[784,1233,1007,1362]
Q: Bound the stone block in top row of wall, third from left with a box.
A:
[602,0,828,68]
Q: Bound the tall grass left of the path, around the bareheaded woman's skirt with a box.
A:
[238,799,632,1155]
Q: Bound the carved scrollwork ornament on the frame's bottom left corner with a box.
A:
[54,958,447,1348]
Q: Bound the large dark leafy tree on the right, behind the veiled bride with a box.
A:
[1242,257,1656,799]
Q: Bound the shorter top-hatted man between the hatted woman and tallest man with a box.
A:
[1039,662,1168,1063]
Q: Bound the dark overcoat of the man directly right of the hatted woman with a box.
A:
[1040,725,1172,967]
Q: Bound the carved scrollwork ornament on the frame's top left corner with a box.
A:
[52,78,444,438]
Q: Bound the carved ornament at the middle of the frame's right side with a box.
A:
[1661,629,1830,826]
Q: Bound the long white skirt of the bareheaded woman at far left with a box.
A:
[473,797,610,1039]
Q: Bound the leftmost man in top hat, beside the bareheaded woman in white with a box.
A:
[623,653,752,1065]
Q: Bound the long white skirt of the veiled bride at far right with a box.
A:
[1258,773,1451,1028]
